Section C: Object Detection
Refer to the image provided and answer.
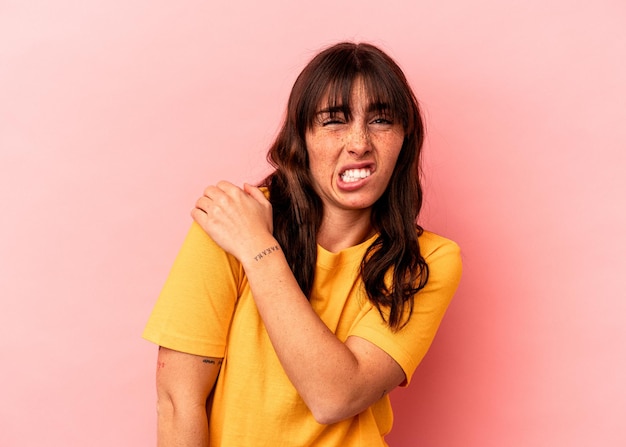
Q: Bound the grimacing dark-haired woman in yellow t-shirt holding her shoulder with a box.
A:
[144,43,461,447]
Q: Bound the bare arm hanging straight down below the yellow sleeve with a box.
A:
[156,347,222,447]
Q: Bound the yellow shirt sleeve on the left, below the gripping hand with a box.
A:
[143,222,243,357]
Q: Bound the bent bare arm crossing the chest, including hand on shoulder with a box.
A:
[192,182,405,424]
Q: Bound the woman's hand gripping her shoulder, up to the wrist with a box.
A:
[191,181,275,262]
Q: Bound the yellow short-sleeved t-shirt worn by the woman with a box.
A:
[143,223,461,447]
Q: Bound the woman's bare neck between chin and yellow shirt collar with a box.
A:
[317,210,374,253]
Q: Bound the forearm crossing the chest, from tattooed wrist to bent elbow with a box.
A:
[241,239,370,419]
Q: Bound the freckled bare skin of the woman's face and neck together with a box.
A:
[306,79,404,251]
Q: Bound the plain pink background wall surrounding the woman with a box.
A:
[0,0,626,447]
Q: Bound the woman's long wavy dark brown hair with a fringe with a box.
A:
[262,42,428,330]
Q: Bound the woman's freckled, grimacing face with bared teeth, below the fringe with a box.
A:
[306,79,404,219]
